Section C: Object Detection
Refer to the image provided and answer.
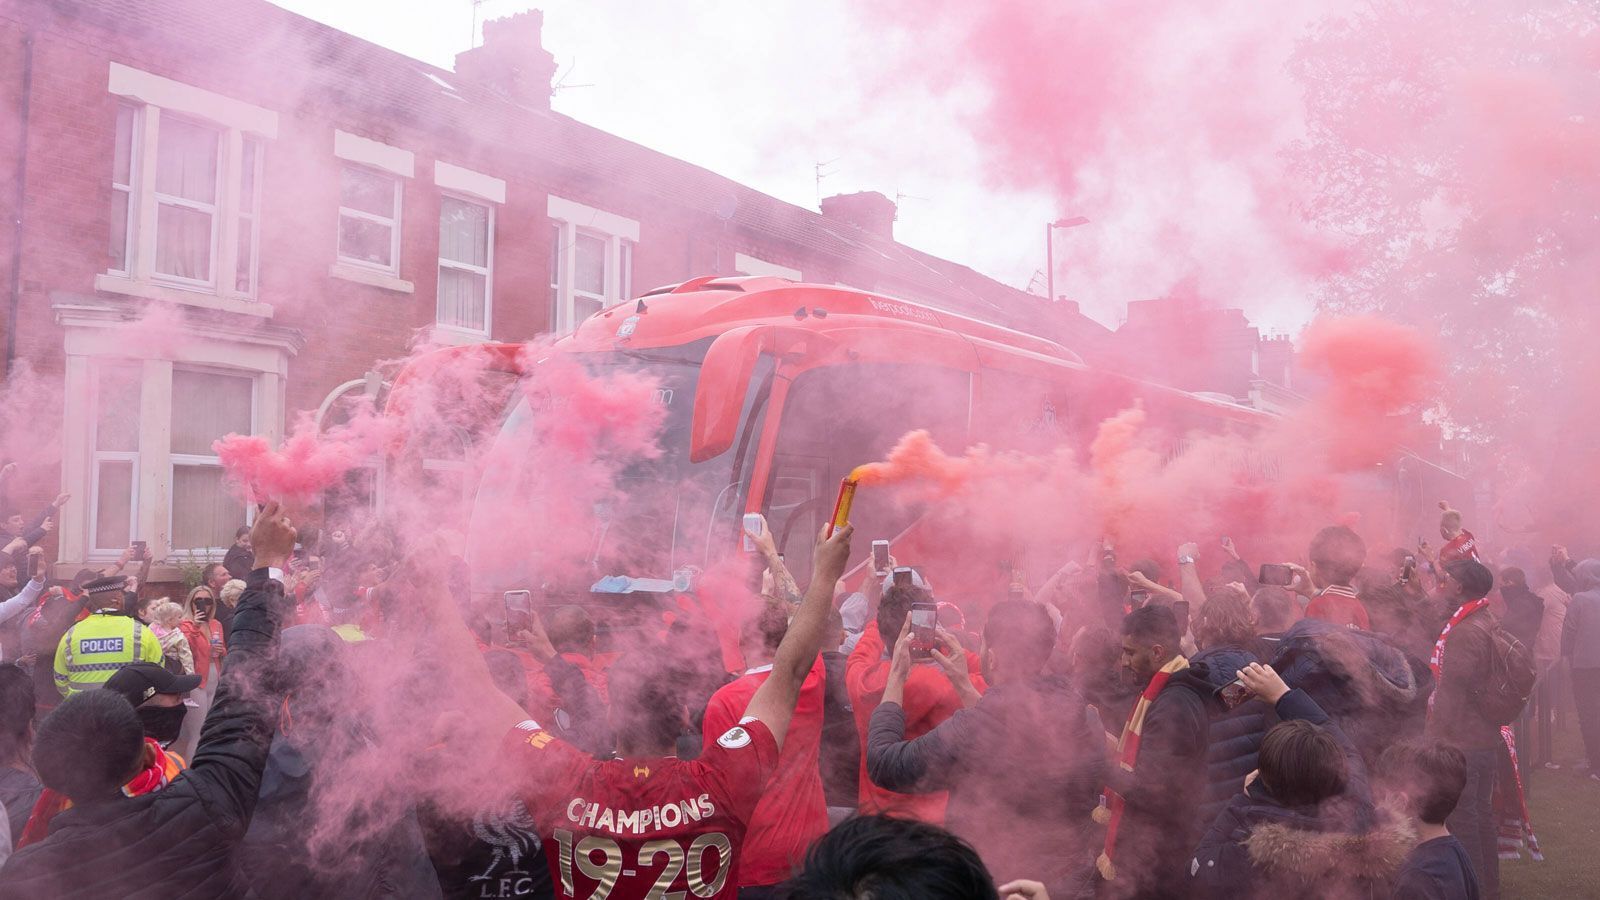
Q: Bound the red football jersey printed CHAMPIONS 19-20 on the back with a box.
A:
[507,719,778,900]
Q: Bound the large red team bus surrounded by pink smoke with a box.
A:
[380,277,1470,604]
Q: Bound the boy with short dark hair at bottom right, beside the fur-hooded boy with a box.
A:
[1378,743,1478,900]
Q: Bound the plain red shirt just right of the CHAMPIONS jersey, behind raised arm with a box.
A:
[701,657,827,887]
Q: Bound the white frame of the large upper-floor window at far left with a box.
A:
[94,62,278,307]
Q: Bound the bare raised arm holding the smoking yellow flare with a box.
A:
[744,525,856,748]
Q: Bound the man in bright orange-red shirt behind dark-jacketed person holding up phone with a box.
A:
[845,573,984,825]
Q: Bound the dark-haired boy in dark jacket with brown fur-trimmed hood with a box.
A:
[1189,663,1413,900]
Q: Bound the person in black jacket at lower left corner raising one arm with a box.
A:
[0,503,294,900]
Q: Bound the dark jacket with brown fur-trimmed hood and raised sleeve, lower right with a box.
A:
[1186,690,1416,900]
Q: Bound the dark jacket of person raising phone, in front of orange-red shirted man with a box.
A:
[867,676,1106,898]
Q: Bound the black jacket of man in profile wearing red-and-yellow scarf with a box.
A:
[1107,665,1218,898]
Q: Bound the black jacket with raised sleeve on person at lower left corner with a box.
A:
[0,570,283,900]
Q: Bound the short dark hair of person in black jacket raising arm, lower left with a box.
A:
[34,689,144,804]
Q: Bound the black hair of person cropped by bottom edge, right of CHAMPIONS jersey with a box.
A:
[778,815,998,900]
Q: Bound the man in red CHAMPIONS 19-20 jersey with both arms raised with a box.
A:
[429,527,854,900]
